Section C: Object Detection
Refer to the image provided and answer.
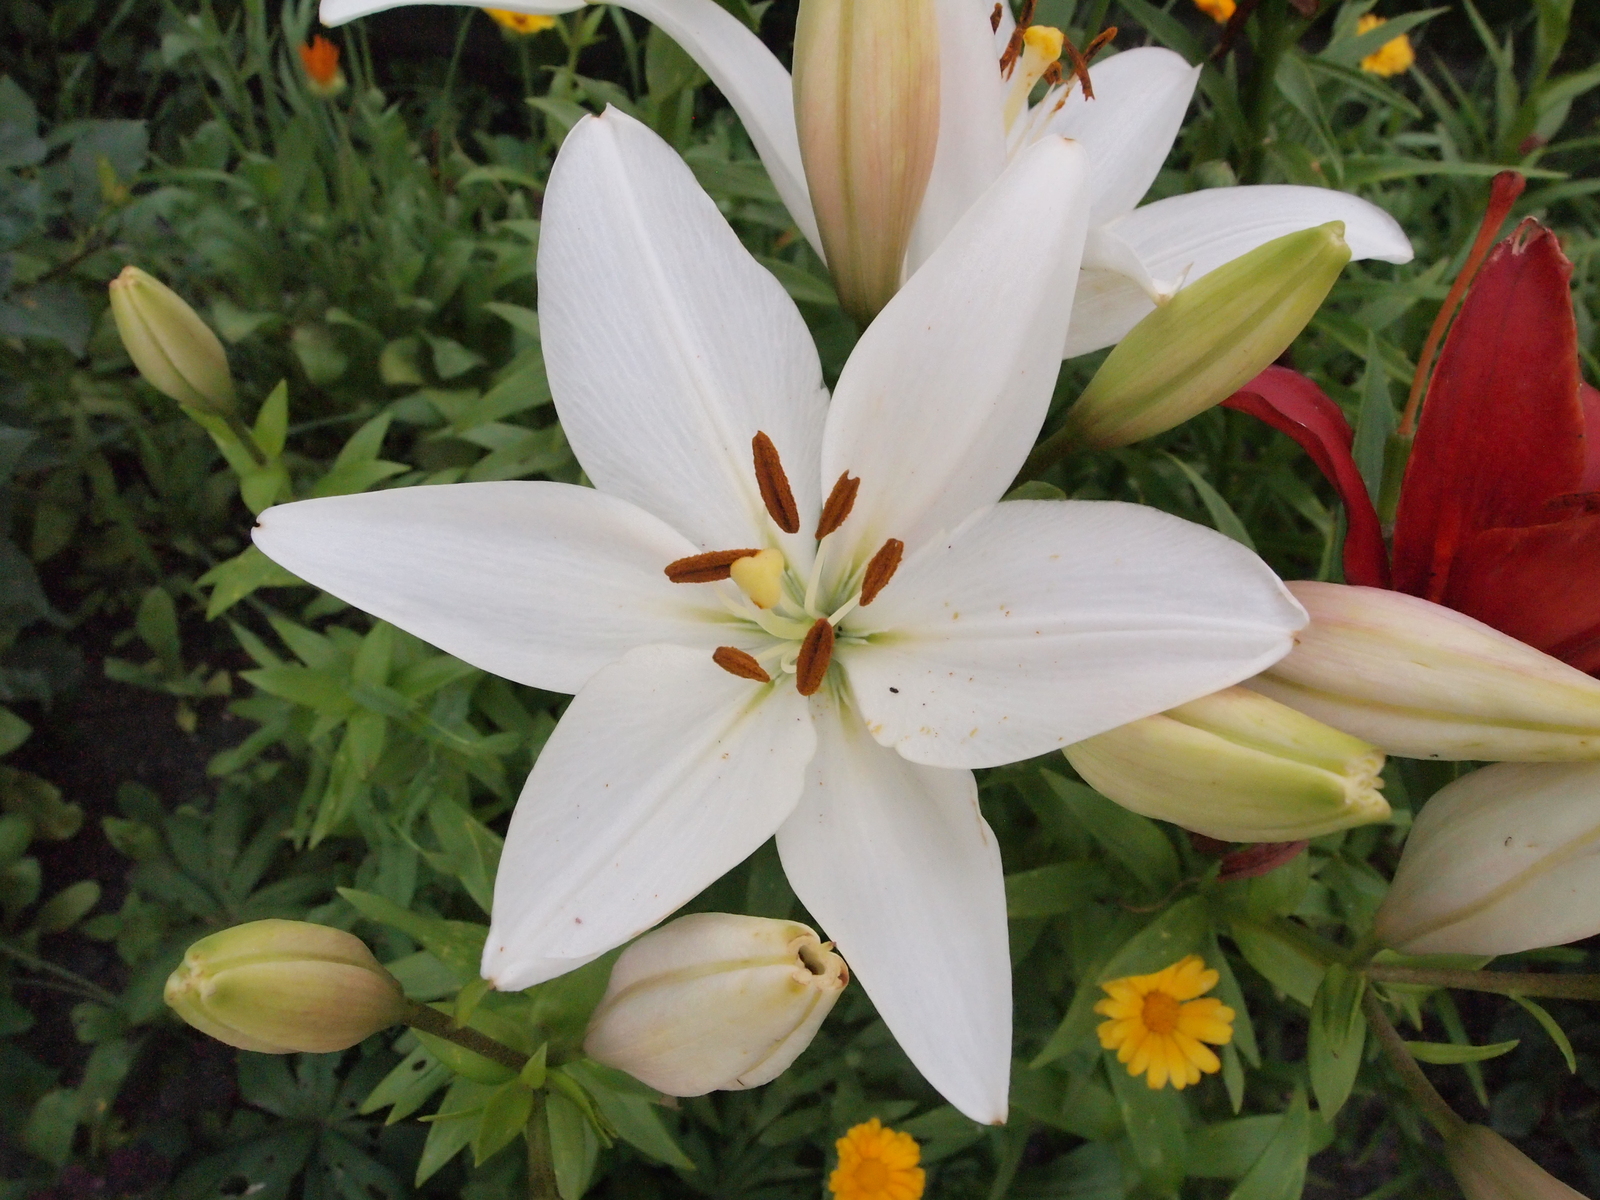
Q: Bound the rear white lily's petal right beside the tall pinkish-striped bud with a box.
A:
[906,0,1010,275]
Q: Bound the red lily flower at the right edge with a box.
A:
[1227,195,1600,674]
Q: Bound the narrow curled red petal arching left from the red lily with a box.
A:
[1222,366,1389,587]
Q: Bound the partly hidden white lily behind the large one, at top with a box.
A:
[322,0,1411,358]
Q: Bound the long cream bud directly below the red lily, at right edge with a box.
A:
[1248,582,1600,762]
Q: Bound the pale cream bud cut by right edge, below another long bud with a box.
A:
[1374,763,1600,954]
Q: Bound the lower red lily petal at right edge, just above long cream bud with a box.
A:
[1443,515,1600,672]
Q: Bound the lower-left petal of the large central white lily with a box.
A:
[483,646,816,992]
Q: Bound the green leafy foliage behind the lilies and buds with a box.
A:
[0,0,1600,1200]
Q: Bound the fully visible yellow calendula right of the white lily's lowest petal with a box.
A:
[1094,954,1234,1090]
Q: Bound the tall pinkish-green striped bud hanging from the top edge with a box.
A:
[794,0,939,325]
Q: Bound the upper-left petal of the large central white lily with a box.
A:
[539,109,827,562]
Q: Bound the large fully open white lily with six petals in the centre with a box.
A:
[256,112,1306,1122]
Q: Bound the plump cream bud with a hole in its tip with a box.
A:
[584,912,850,1096]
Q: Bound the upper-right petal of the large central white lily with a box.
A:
[822,138,1088,562]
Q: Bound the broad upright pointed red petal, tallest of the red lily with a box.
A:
[1394,219,1584,601]
